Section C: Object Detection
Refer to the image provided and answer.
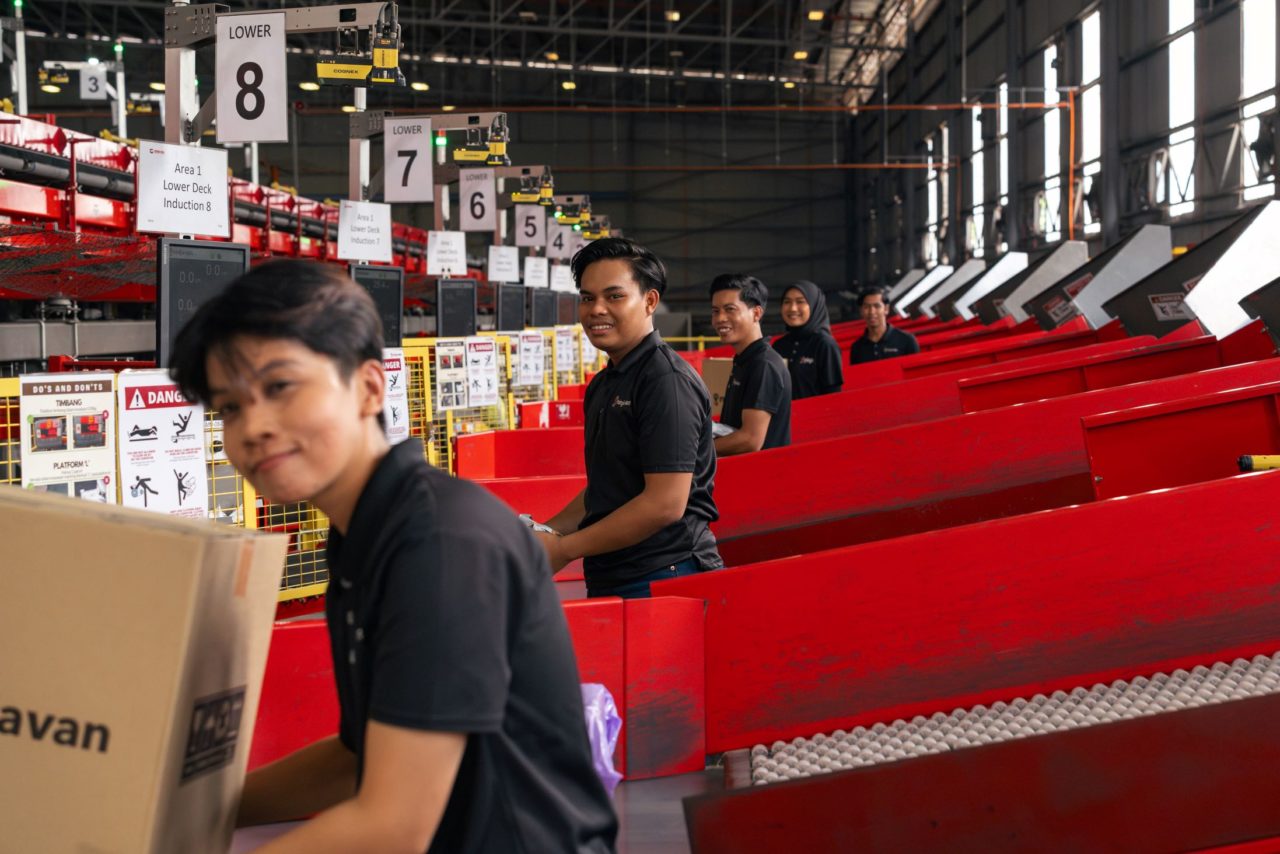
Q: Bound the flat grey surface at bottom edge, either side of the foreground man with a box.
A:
[232,768,724,854]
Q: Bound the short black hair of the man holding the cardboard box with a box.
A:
[169,260,383,423]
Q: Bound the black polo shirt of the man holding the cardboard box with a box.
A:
[325,439,617,853]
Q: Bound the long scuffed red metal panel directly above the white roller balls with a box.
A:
[654,472,1280,752]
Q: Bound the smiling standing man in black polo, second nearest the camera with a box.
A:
[539,237,724,598]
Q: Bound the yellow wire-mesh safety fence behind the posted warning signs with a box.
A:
[0,326,586,602]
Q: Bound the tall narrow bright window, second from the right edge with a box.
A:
[1161,0,1192,216]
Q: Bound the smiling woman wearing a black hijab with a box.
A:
[773,282,845,401]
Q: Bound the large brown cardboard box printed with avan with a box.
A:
[0,487,287,854]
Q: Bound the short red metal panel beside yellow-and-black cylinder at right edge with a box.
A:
[1083,382,1280,499]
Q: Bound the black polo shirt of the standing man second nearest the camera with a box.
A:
[580,332,724,589]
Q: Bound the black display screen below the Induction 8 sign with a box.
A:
[156,237,250,367]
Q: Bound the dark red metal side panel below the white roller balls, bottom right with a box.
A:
[685,695,1280,854]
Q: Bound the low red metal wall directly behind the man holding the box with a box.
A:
[250,597,707,780]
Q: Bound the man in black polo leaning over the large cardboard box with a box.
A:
[172,261,617,854]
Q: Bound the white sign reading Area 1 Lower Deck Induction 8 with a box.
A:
[137,141,232,237]
